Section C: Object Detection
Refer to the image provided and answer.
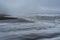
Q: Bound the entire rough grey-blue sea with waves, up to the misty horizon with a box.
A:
[0,14,60,40]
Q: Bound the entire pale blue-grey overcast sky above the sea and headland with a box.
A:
[0,0,60,15]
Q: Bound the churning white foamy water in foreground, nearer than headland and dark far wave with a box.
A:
[0,18,60,40]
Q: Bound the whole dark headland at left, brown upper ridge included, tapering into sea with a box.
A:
[0,14,33,23]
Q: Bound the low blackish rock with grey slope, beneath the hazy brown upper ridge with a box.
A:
[0,17,33,23]
